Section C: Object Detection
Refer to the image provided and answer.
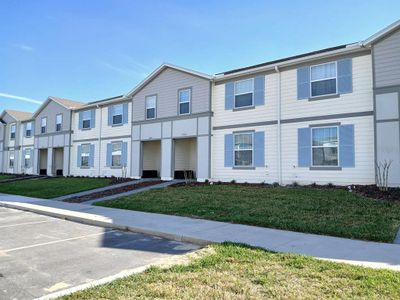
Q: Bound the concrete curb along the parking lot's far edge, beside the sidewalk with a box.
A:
[0,202,214,246]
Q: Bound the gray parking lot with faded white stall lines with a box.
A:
[0,207,197,300]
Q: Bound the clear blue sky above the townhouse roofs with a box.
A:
[0,0,400,111]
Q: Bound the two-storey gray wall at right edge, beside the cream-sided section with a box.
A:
[372,30,400,186]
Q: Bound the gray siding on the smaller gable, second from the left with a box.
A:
[35,101,71,135]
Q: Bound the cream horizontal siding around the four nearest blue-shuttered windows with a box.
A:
[212,52,375,185]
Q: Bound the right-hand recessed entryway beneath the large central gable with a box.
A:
[174,138,197,179]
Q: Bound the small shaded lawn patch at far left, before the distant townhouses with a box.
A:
[0,177,111,199]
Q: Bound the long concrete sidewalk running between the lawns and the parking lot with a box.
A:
[0,194,400,271]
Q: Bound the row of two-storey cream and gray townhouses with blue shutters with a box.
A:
[0,22,400,186]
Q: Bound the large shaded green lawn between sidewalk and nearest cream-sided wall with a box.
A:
[96,185,400,242]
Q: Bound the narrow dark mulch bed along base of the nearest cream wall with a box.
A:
[170,181,400,202]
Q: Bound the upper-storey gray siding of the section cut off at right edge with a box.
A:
[373,30,400,87]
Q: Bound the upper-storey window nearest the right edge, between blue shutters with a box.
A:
[310,62,337,97]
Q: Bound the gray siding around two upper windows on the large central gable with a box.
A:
[133,68,211,121]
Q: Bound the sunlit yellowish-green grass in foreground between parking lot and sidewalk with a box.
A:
[62,243,400,300]
